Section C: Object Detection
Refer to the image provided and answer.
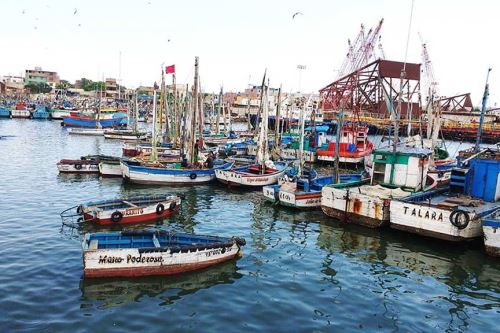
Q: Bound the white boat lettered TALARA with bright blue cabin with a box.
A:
[390,149,500,241]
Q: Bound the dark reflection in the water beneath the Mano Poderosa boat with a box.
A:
[80,260,243,309]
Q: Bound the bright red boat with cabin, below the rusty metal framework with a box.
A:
[316,124,373,164]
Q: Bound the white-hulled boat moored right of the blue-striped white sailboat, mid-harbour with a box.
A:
[215,162,287,187]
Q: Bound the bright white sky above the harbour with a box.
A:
[0,0,500,107]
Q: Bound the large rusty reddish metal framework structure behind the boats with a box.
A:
[319,59,421,119]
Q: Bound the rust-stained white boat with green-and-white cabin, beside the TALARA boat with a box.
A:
[321,146,436,228]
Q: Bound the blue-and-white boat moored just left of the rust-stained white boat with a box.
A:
[262,174,369,209]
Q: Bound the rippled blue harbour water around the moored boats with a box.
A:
[0,120,500,332]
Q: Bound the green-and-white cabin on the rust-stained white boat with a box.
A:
[371,146,432,191]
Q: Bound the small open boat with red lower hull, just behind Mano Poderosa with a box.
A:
[60,195,181,225]
